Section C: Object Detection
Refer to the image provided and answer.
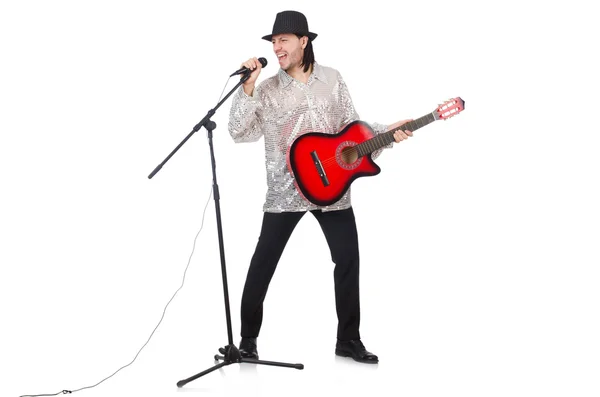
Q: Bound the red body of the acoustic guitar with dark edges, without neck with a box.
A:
[287,120,381,206]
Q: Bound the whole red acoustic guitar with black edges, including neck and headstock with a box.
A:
[287,97,465,206]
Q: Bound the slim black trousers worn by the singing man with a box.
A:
[241,208,360,340]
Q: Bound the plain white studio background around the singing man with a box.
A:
[0,0,600,397]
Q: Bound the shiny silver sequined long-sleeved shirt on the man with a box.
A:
[229,63,392,212]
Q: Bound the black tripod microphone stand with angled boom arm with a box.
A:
[148,70,304,387]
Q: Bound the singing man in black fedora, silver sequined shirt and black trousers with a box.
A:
[229,11,412,363]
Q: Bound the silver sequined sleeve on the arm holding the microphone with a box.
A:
[229,87,263,143]
